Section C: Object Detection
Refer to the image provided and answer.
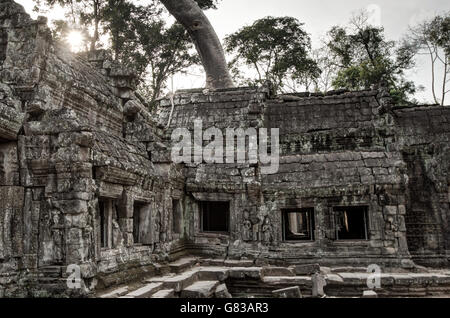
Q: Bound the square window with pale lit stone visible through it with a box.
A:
[283,209,314,241]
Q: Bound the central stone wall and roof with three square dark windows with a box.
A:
[159,85,418,265]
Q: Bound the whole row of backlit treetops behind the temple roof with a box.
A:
[29,0,450,105]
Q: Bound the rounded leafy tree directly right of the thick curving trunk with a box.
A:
[225,17,320,91]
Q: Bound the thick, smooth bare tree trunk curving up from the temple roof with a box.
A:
[161,0,233,88]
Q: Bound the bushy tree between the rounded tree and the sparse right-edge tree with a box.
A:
[327,13,416,104]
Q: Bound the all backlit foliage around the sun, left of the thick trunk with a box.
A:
[34,0,210,101]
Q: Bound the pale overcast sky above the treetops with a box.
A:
[16,0,450,102]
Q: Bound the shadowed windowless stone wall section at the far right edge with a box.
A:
[393,107,450,263]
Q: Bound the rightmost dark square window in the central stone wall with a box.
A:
[334,207,368,240]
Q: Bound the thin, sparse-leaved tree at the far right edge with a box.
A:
[403,12,450,105]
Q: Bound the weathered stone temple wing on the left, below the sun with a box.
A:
[0,1,183,296]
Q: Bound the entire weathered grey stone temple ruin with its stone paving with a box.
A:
[0,0,450,297]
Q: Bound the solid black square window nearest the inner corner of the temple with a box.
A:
[201,202,230,233]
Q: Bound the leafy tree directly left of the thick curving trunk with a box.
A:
[108,0,217,102]
